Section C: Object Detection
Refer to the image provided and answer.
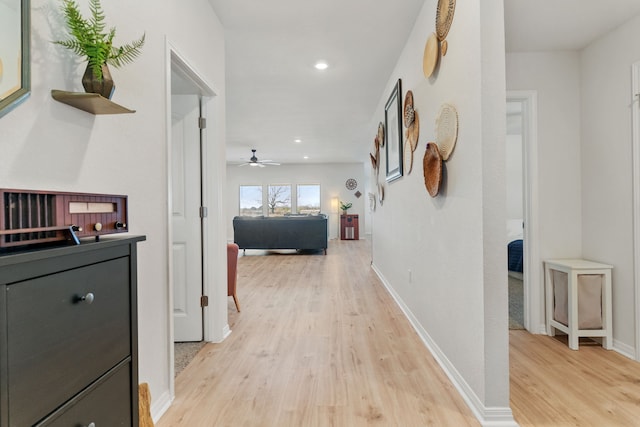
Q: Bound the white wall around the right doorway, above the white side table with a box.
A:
[506,52,582,260]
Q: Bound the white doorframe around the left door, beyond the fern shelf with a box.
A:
[165,38,216,400]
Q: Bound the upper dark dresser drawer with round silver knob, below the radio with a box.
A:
[6,257,131,426]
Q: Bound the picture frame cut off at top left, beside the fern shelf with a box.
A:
[0,0,31,117]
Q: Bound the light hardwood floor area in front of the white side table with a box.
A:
[509,330,640,427]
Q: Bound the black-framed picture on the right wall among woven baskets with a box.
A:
[384,79,403,182]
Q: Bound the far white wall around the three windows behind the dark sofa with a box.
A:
[226,163,369,241]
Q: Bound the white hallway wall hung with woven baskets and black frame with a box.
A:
[363,0,513,425]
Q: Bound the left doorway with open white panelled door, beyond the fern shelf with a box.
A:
[167,47,217,388]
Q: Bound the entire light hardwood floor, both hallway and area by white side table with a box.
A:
[156,241,640,427]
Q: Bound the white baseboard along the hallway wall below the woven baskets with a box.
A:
[371,263,518,427]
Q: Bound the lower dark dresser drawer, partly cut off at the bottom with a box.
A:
[36,363,133,427]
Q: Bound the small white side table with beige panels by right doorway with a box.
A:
[544,259,613,350]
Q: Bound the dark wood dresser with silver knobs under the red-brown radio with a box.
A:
[0,236,145,427]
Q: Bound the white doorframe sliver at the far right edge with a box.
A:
[631,61,640,361]
